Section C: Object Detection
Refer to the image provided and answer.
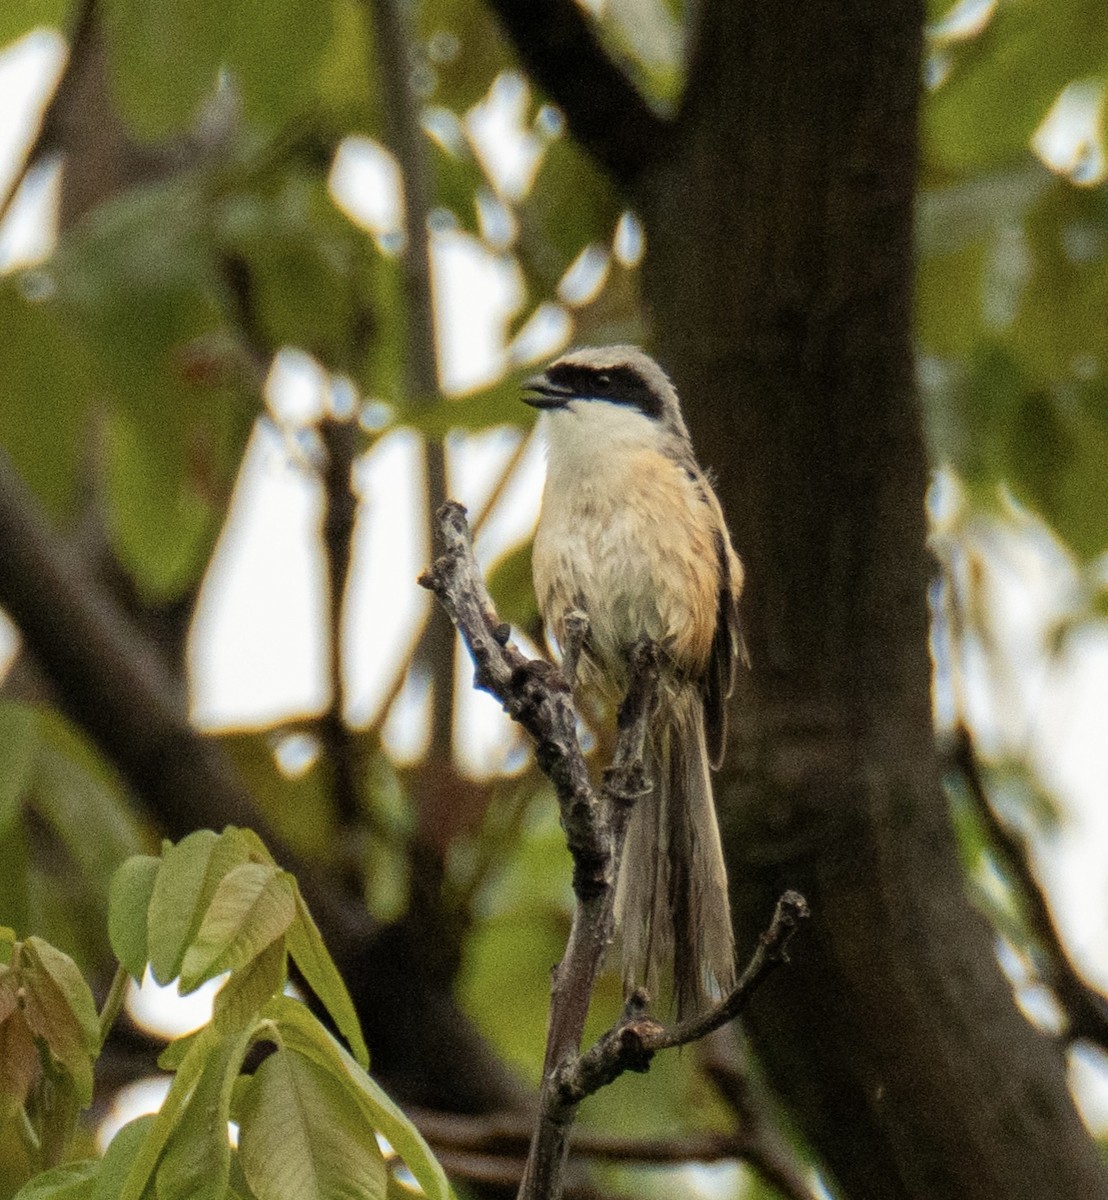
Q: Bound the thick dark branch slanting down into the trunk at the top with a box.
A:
[489,0,671,191]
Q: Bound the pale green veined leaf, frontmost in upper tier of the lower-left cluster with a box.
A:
[180,863,297,992]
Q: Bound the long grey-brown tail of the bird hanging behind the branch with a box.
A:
[616,685,735,1019]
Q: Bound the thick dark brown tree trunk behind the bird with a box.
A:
[639,0,1108,1200]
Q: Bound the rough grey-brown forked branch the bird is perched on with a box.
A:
[420,502,808,1200]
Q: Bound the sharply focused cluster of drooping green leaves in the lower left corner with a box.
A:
[0,828,453,1200]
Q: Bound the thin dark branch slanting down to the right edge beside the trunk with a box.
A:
[953,725,1108,1050]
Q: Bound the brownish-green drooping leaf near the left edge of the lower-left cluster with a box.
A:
[22,936,100,1106]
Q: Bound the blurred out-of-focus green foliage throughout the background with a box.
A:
[0,0,1108,1194]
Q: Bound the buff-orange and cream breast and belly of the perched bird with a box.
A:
[533,450,719,686]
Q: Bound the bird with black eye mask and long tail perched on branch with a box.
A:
[523,346,745,1016]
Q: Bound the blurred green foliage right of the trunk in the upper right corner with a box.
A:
[917,0,1108,560]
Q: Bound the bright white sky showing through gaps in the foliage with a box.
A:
[0,16,1108,1161]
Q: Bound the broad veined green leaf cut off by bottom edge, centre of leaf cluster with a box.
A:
[239,1050,388,1200]
